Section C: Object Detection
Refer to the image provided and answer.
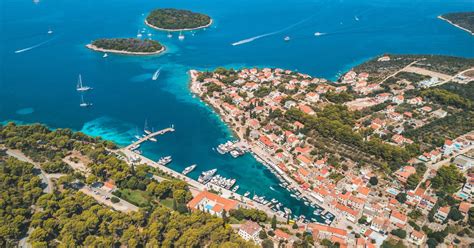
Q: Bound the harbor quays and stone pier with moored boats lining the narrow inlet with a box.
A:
[120,124,334,224]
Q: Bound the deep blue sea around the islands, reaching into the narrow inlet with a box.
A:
[0,0,474,221]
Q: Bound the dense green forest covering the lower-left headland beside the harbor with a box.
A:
[0,123,258,247]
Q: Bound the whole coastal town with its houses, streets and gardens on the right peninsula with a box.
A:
[190,55,474,247]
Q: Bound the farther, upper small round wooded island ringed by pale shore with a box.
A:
[145,9,212,31]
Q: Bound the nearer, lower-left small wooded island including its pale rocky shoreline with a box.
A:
[86,38,165,55]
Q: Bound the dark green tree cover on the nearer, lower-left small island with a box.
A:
[92,38,163,53]
